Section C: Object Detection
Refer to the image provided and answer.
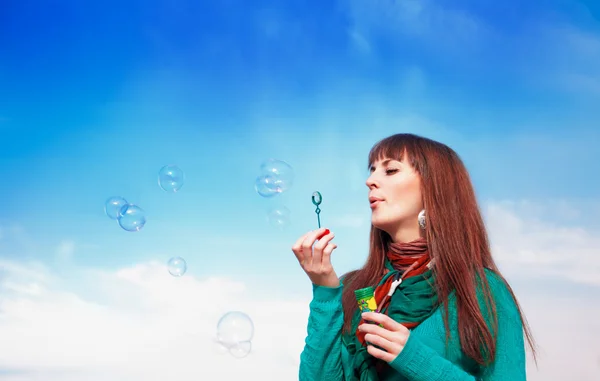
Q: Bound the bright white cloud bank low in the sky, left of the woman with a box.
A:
[0,262,308,380]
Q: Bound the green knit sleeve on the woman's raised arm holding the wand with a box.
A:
[299,284,344,381]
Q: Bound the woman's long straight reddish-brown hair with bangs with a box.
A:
[342,134,535,365]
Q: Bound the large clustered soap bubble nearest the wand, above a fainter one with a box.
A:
[255,159,294,197]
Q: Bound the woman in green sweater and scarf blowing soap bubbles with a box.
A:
[292,134,535,381]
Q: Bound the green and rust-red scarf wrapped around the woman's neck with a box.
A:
[342,238,437,381]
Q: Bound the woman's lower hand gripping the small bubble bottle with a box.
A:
[358,312,410,363]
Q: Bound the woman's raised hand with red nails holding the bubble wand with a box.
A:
[292,228,340,287]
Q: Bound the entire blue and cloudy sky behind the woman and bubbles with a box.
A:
[0,0,600,381]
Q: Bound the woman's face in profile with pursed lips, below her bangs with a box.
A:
[366,159,423,241]
